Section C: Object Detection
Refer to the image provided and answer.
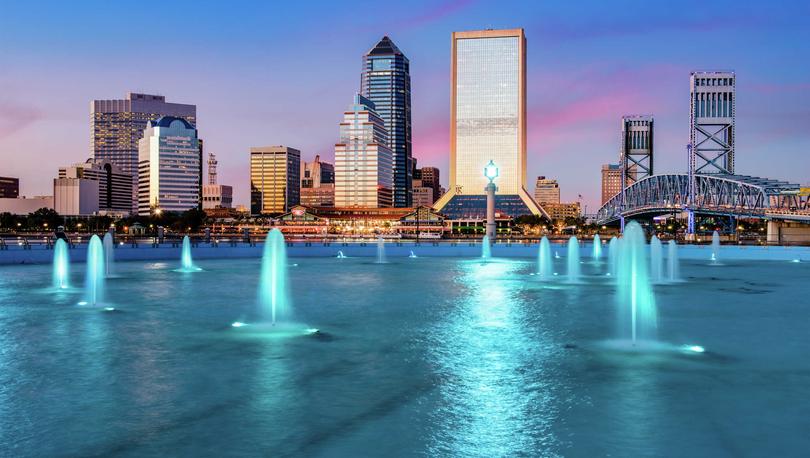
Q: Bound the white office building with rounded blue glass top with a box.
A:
[138,116,202,216]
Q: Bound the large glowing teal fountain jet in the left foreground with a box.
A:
[259,229,291,324]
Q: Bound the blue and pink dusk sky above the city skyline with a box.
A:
[0,0,810,213]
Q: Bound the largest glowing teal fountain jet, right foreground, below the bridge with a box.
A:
[616,221,657,347]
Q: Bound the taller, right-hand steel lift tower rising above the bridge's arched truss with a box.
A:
[689,72,737,174]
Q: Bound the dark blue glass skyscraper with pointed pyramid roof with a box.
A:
[360,36,413,207]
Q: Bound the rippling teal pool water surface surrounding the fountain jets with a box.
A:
[0,256,810,457]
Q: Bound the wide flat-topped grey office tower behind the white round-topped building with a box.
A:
[90,92,197,215]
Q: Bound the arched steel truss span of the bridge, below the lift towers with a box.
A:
[597,173,810,227]
